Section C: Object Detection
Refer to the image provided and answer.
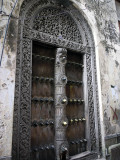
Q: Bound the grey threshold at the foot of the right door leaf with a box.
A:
[70,151,97,160]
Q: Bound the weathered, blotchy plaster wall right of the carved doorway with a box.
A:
[83,0,120,155]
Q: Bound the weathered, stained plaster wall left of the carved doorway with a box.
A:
[0,0,18,158]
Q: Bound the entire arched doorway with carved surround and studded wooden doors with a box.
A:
[13,0,100,160]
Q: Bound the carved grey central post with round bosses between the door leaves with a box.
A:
[55,48,69,160]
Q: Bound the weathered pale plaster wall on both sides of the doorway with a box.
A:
[0,0,120,158]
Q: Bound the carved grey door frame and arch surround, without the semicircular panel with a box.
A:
[12,0,101,160]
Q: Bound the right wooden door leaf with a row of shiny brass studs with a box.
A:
[66,52,86,156]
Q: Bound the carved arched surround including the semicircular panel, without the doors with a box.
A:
[13,0,101,160]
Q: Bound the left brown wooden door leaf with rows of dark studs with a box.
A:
[31,43,55,160]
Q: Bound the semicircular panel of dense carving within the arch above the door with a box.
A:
[33,7,81,43]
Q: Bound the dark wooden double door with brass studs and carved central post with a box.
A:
[31,42,87,160]
